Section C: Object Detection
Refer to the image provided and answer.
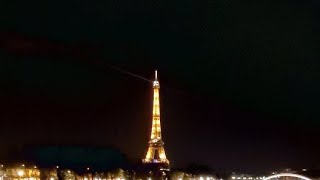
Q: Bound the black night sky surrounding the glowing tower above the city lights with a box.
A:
[0,0,320,171]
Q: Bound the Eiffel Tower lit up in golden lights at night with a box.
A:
[142,71,169,169]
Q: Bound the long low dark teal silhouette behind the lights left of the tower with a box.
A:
[15,146,130,174]
